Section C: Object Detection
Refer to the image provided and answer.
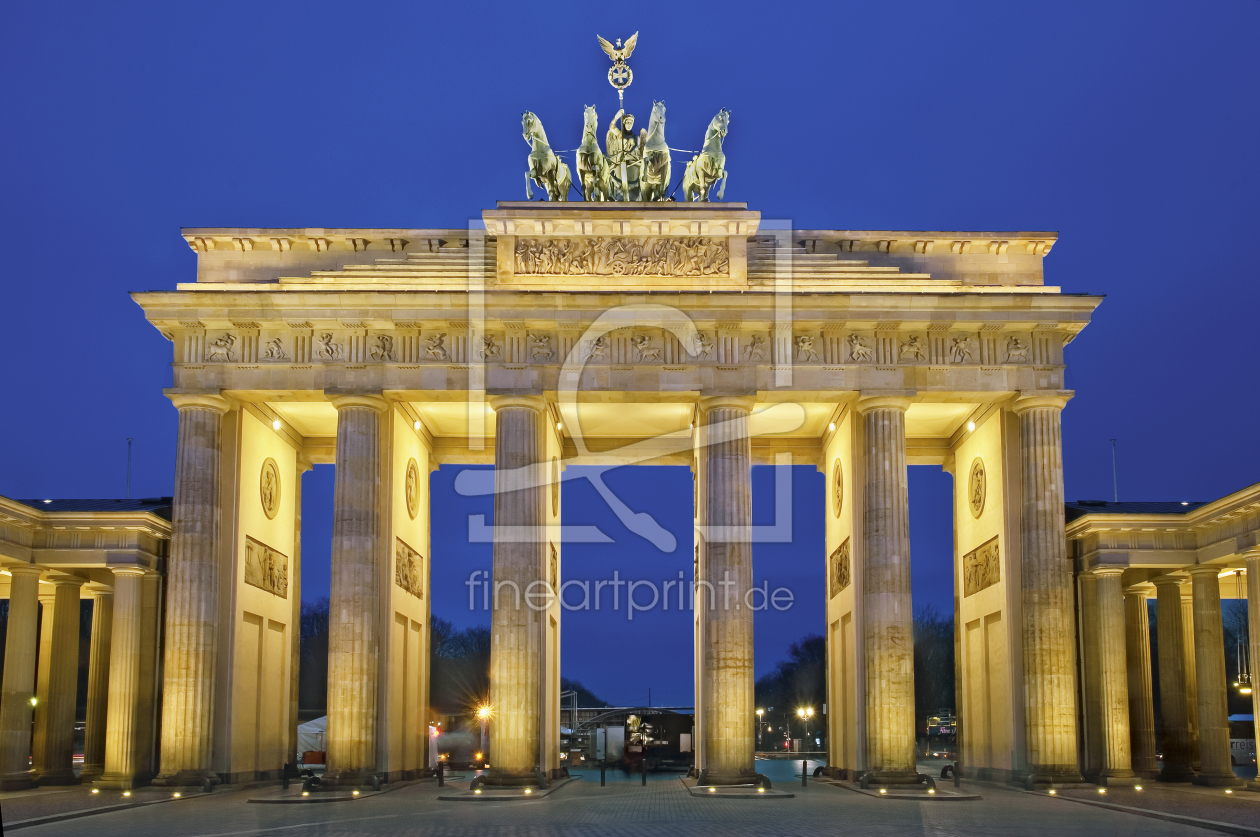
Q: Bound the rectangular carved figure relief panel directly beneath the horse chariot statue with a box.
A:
[513,237,731,276]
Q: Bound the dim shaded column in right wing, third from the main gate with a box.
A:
[1154,576,1193,782]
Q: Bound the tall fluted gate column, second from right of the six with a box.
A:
[857,397,919,784]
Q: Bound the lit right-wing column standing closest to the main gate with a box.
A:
[1094,567,1137,784]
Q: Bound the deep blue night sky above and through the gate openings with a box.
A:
[0,0,1260,703]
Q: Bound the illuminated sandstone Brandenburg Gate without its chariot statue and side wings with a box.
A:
[122,199,1100,784]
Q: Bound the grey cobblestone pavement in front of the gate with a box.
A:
[7,774,1218,837]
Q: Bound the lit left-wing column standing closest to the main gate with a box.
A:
[93,567,146,790]
